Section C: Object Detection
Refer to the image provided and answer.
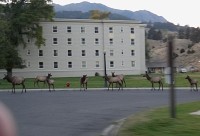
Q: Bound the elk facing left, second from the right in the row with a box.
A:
[143,71,163,91]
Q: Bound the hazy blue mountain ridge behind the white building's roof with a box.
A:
[53,1,168,23]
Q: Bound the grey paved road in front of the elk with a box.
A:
[0,89,200,136]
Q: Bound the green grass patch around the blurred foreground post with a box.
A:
[117,102,200,136]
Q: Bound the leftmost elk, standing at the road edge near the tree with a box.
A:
[3,75,26,93]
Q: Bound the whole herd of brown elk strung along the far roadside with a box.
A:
[0,71,198,93]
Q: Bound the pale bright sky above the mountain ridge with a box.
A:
[53,0,200,27]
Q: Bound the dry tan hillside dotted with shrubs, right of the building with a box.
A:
[147,39,200,68]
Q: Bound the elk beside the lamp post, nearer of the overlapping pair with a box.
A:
[104,75,123,90]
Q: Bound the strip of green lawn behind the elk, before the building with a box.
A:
[0,73,200,89]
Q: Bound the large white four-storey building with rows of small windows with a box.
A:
[3,19,146,77]
